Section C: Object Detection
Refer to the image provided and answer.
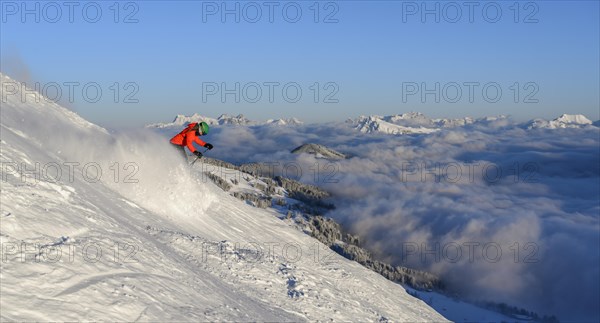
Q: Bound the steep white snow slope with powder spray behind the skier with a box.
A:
[0,76,444,322]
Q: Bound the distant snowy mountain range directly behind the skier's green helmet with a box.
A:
[146,113,303,128]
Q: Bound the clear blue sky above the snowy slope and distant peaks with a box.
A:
[0,0,600,127]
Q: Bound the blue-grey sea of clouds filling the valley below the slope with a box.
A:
[154,118,600,321]
